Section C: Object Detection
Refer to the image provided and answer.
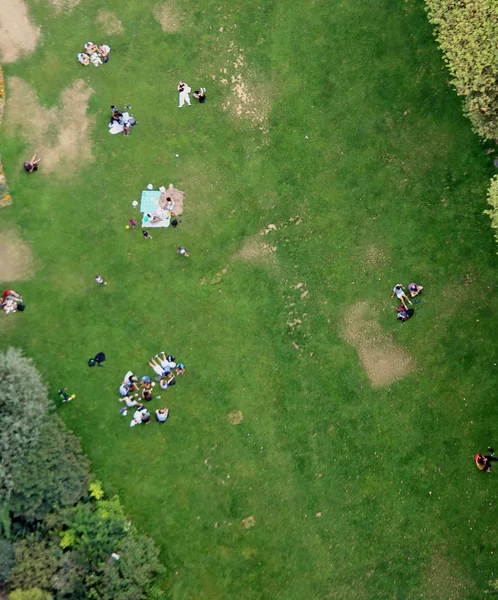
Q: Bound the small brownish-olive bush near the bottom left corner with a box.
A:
[7,539,58,590]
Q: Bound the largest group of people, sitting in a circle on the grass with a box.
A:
[119,352,185,427]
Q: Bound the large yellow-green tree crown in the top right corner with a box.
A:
[425,0,498,139]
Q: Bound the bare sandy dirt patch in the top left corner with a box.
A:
[0,0,41,63]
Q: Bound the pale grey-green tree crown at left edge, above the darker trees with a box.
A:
[0,348,50,503]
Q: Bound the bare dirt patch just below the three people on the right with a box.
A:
[344,302,412,386]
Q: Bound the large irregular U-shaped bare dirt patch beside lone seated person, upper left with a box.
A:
[5,77,93,176]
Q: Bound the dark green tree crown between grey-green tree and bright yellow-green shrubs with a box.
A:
[10,415,90,521]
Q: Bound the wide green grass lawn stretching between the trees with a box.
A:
[0,0,498,600]
